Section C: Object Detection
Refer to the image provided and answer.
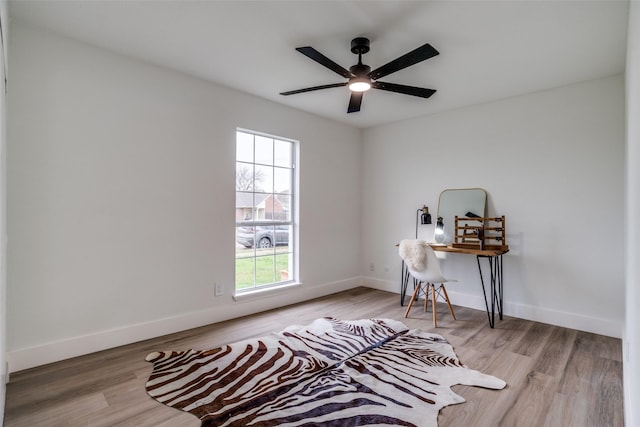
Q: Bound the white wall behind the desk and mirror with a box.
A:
[361,76,625,337]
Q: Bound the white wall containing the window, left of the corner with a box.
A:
[7,22,361,371]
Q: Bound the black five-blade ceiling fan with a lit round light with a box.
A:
[280,37,440,113]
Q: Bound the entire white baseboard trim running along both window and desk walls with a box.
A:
[7,277,623,375]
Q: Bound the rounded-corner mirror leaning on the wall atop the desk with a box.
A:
[433,188,487,245]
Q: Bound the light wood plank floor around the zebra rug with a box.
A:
[5,288,624,427]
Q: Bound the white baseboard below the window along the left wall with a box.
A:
[7,276,362,373]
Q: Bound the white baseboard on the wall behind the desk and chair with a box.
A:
[362,277,623,338]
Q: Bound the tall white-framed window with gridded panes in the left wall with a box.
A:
[236,130,296,292]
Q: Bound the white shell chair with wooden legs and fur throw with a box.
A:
[404,245,456,327]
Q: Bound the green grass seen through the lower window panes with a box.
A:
[236,253,289,289]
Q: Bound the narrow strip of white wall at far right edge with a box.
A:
[623,1,640,427]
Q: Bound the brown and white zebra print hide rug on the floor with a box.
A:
[146,318,506,427]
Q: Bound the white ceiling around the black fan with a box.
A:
[9,0,628,128]
